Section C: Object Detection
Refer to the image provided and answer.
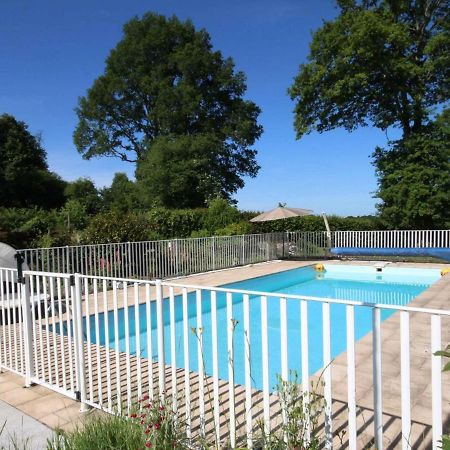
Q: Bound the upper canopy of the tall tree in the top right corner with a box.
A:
[289,0,450,137]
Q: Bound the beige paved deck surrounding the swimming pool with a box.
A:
[0,261,450,449]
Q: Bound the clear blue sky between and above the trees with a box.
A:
[0,0,392,215]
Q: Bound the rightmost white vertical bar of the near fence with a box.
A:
[431,314,442,449]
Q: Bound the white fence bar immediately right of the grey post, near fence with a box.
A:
[400,311,411,450]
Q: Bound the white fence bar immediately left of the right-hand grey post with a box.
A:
[346,305,356,450]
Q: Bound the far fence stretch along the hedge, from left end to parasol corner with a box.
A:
[20,233,287,279]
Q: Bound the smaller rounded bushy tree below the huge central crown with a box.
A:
[136,134,258,208]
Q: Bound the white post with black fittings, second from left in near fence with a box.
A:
[70,273,88,412]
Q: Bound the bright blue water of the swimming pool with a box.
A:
[79,264,440,388]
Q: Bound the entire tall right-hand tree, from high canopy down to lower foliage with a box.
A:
[289,0,450,227]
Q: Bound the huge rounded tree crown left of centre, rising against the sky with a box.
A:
[74,13,262,206]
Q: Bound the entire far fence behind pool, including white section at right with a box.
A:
[20,230,450,279]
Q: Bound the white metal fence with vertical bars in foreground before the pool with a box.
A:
[0,269,450,449]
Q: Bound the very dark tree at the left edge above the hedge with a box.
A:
[0,114,65,208]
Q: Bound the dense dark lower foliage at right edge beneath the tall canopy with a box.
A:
[374,110,450,229]
